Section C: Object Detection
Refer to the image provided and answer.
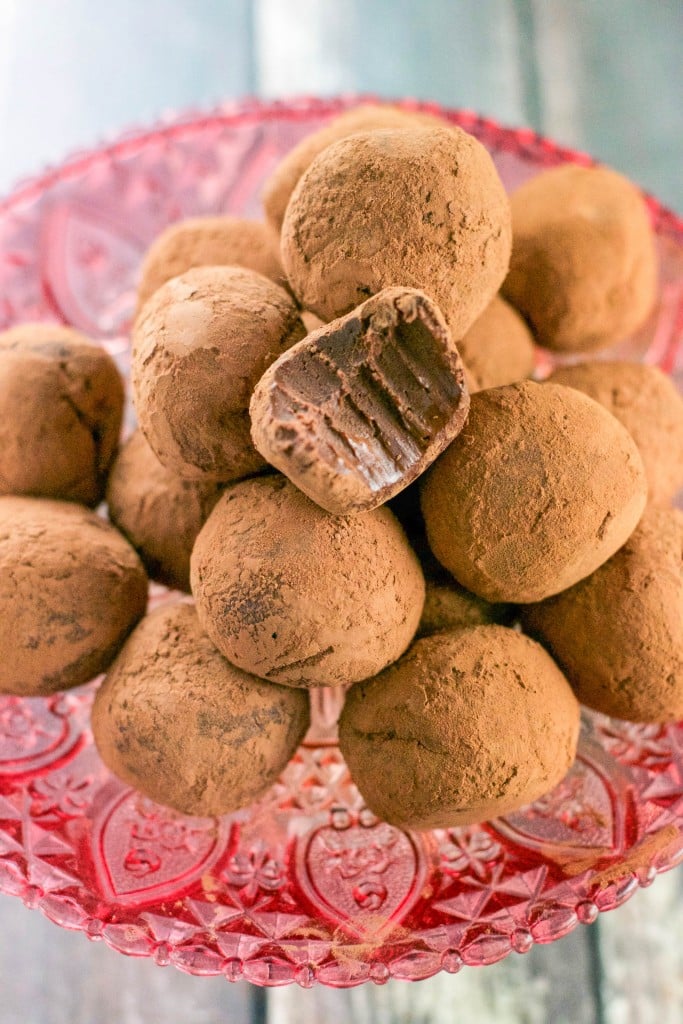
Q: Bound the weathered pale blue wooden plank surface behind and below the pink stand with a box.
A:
[0,0,683,1024]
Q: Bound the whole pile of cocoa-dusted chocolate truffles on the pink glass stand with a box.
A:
[0,106,683,829]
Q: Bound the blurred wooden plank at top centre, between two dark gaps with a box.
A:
[254,0,524,123]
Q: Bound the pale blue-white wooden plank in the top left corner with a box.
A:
[0,0,253,193]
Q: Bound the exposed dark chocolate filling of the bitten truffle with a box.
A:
[270,298,465,493]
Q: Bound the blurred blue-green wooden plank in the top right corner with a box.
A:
[528,0,683,211]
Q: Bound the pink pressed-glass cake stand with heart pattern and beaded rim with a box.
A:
[0,99,683,987]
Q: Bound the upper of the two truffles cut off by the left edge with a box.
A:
[0,324,124,505]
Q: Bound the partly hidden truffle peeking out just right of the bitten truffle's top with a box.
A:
[458,295,535,393]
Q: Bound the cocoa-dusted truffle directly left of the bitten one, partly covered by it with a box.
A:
[131,266,305,481]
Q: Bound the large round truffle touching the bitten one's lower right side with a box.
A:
[421,381,647,603]
